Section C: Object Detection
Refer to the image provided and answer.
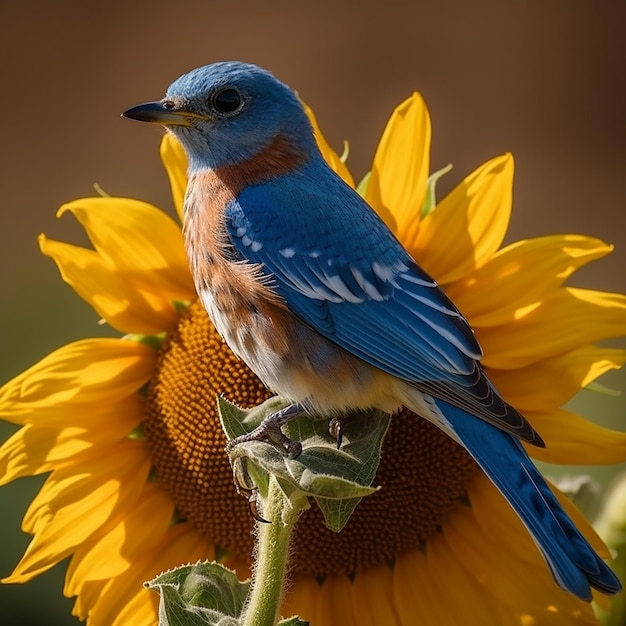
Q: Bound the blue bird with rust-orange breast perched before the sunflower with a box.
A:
[122,61,621,601]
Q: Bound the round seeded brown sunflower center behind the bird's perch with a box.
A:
[145,302,475,578]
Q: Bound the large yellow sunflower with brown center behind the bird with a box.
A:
[0,94,626,626]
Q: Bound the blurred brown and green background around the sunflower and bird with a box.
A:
[0,0,626,626]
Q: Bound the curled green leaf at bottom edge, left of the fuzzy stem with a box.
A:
[144,562,250,626]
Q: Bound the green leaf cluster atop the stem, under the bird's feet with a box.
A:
[220,398,390,532]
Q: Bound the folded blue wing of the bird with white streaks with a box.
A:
[226,162,542,445]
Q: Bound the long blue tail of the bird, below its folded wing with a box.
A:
[434,399,621,601]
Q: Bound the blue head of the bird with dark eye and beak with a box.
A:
[123,61,316,172]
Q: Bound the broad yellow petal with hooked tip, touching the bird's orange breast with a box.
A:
[57,198,195,300]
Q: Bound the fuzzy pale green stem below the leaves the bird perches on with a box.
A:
[241,476,295,626]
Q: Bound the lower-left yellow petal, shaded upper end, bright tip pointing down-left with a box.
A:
[64,483,174,596]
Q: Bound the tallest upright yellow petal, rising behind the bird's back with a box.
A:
[365,93,431,236]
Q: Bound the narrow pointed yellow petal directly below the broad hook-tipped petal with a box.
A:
[39,235,178,334]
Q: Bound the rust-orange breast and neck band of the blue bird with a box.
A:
[179,135,306,352]
